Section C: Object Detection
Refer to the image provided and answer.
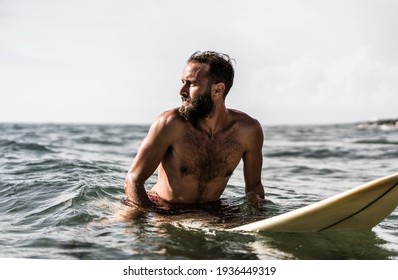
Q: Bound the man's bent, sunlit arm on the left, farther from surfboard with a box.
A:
[124,112,173,208]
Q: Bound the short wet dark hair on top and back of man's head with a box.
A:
[187,51,235,98]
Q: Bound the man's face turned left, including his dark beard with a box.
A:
[179,62,214,122]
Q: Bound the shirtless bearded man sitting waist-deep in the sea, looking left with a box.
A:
[122,52,264,210]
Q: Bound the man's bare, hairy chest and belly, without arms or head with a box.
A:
[152,108,250,203]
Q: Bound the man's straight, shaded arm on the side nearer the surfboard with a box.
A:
[243,120,264,201]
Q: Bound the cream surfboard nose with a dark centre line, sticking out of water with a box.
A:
[229,173,398,232]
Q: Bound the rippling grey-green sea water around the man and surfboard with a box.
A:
[0,124,398,260]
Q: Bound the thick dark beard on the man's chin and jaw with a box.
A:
[178,91,214,122]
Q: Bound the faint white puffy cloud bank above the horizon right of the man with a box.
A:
[249,46,398,123]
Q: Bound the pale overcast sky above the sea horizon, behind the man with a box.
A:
[0,0,398,124]
